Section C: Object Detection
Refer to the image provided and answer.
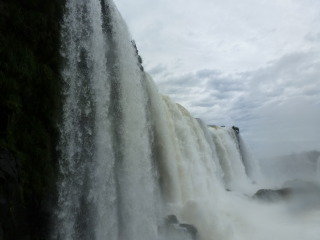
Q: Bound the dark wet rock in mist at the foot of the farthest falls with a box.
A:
[253,188,292,202]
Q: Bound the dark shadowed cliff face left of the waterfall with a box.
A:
[0,0,63,240]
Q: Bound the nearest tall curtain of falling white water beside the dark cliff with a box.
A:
[54,0,157,239]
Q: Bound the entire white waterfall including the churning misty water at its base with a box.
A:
[51,0,319,240]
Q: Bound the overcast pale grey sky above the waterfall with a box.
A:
[115,0,320,157]
